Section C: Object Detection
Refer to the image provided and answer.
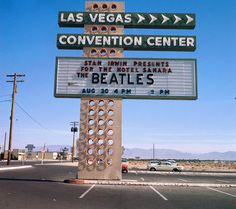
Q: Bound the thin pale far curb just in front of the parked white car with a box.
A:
[129,171,236,176]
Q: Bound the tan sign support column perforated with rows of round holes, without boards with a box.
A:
[77,2,124,180]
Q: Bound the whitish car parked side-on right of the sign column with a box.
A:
[147,161,184,172]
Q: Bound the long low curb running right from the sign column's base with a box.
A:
[64,179,236,188]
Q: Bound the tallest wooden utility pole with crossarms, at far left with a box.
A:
[7,73,25,165]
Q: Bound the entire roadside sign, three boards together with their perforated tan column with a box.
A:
[54,1,197,180]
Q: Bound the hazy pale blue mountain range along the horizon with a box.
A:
[34,145,236,161]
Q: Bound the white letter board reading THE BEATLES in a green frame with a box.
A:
[54,57,197,100]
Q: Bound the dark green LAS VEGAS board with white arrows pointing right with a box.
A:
[58,12,195,29]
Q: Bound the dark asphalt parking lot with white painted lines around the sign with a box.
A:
[0,165,236,209]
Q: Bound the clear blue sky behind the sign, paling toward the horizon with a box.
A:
[0,0,236,153]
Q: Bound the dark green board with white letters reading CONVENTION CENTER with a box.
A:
[57,34,196,51]
